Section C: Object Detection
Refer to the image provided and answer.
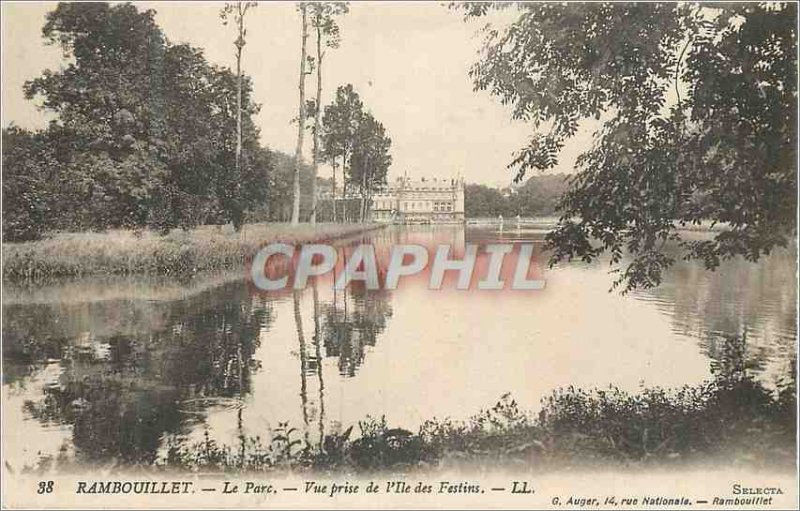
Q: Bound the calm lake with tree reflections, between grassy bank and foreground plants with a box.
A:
[2,226,797,467]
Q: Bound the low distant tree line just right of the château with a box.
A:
[464,174,569,218]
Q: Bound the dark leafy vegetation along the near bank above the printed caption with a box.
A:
[155,338,797,472]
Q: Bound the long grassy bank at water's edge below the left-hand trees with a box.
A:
[3,224,381,280]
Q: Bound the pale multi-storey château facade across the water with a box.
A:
[371,176,464,224]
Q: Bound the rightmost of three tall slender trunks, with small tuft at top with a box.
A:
[310,2,348,224]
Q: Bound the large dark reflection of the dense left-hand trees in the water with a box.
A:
[3,283,271,463]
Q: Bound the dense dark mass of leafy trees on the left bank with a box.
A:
[3,3,273,240]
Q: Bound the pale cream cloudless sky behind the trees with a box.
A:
[2,2,591,186]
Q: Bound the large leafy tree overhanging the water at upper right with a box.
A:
[459,3,797,291]
